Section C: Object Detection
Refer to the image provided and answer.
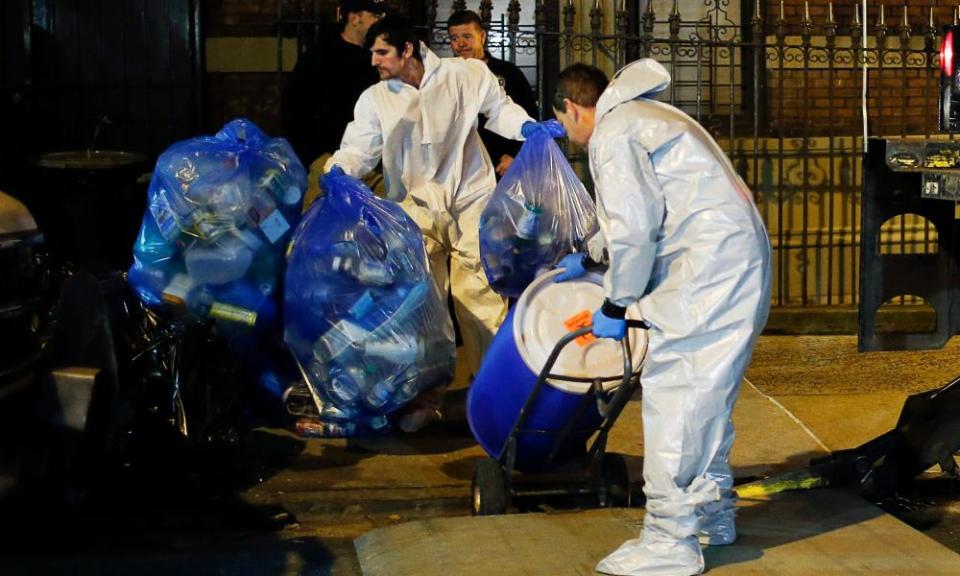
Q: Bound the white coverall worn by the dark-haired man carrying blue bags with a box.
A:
[325,43,533,374]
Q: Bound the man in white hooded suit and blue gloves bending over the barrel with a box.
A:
[553,59,771,576]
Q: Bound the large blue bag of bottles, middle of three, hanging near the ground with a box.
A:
[284,167,455,436]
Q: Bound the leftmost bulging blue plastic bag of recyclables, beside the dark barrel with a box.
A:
[128,119,307,346]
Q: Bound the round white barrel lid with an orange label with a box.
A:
[513,270,647,394]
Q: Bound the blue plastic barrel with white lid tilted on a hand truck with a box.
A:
[467,271,646,472]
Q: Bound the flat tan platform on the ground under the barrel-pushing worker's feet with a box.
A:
[356,490,960,576]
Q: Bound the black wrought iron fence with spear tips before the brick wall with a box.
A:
[276,0,956,306]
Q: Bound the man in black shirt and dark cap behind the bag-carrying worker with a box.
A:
[280,0,386,182]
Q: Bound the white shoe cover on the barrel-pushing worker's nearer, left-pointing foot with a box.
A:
[597,530,703,576]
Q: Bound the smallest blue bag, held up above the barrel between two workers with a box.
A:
[480,132,597,298]
